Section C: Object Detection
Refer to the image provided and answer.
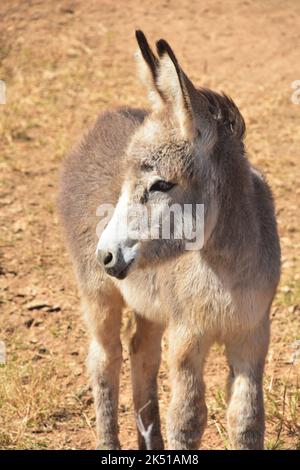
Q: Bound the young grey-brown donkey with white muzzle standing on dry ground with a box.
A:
[59,31,280,449]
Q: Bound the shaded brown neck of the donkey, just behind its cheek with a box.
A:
[203,143,258,262]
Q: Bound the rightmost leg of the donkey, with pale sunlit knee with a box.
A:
[226,318,269,450]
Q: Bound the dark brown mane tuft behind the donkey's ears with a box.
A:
[197,88,246,141]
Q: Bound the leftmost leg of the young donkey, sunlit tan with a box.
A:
[83,285,123,450]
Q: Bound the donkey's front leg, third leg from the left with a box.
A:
[167,328,209,450]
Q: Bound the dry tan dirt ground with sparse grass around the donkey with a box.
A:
[0,0,300,449]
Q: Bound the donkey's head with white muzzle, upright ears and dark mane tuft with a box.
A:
[97,31,243,279]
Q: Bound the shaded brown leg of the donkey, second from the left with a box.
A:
[130,315,164,450]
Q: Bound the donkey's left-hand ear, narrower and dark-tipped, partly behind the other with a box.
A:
[135,30,163,109]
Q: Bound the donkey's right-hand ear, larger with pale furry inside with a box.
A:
[156,39,197,140]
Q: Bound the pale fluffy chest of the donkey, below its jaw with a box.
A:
[117,263,267,337]
